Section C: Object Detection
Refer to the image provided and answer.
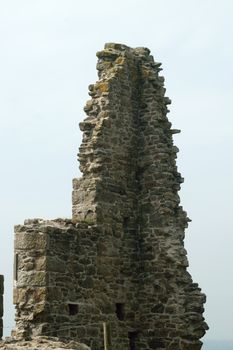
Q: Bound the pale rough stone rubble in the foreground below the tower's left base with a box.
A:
[0,337,90,350]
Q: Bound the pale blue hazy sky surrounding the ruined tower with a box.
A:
[0,0,233,339]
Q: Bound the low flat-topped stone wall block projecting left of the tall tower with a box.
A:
[14,219,134,350]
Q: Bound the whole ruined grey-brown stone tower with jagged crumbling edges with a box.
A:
[14,44,207,350]
